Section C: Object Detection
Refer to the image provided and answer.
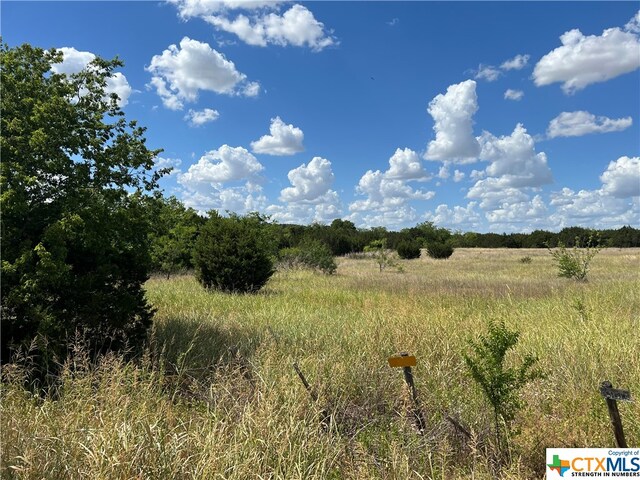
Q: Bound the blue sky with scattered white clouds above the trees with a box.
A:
[1,0,640,233]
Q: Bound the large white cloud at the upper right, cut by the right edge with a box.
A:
[533,11,640,94]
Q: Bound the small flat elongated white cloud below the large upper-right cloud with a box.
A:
[547,110,633,138]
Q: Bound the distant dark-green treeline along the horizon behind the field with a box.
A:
[146,195,640,275]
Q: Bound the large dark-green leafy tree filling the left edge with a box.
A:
[0,44,163,361]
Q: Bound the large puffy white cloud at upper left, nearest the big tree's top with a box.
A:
[146,37,257,110]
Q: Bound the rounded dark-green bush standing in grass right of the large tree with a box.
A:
[193,212,274,293]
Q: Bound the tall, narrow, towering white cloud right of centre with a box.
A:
[424,80,480,163]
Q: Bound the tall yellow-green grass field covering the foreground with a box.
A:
[1,249,640,479]
